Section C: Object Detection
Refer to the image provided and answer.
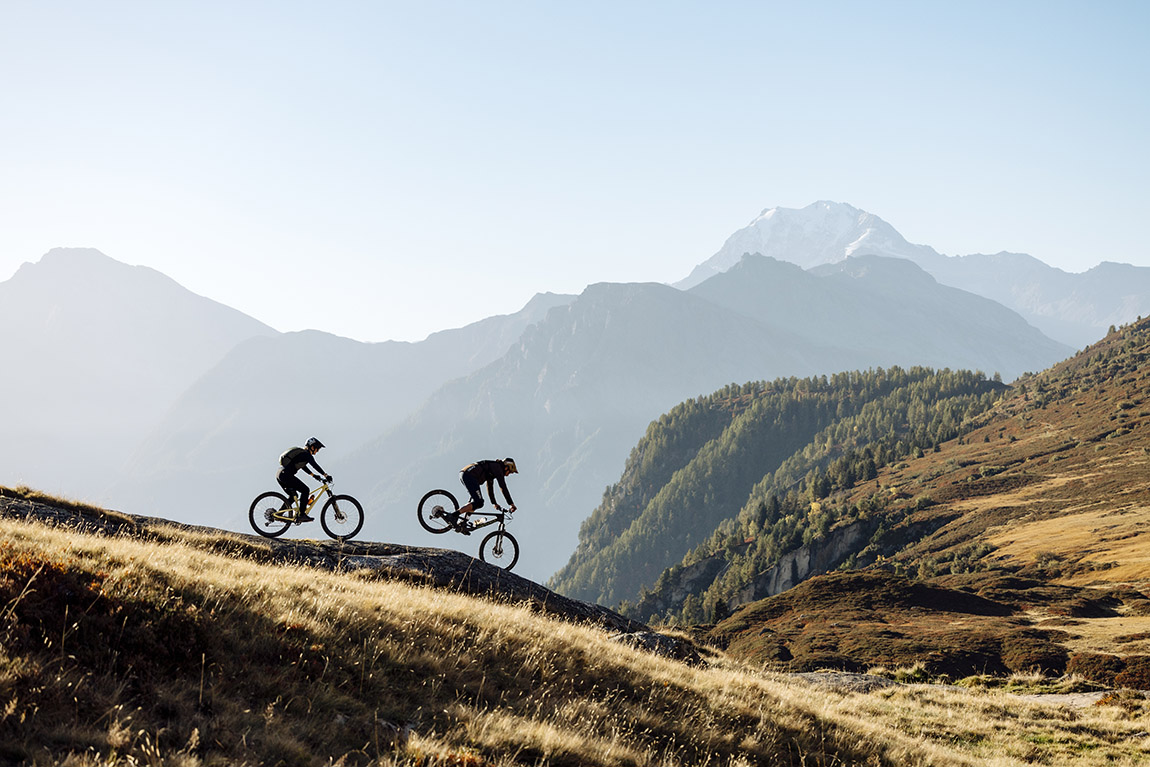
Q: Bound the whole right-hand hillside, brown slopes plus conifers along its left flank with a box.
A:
[605,320,1150,687]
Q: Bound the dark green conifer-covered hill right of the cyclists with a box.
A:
[551,368,1005,614]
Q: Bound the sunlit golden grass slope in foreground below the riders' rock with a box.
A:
[0,505,1150,766]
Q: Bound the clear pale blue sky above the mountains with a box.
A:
[0,0,1150,340]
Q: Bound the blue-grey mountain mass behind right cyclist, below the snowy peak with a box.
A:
[338,265,1072,576]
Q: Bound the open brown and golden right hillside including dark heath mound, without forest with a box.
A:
[713,321,1150,689]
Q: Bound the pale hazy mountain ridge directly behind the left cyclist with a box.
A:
[113,293,572,528]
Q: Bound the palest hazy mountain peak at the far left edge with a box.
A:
[0,248,277,499]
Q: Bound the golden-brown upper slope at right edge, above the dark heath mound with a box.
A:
[860,321,1150,586]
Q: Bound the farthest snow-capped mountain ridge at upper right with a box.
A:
[675,200,1150,348]
